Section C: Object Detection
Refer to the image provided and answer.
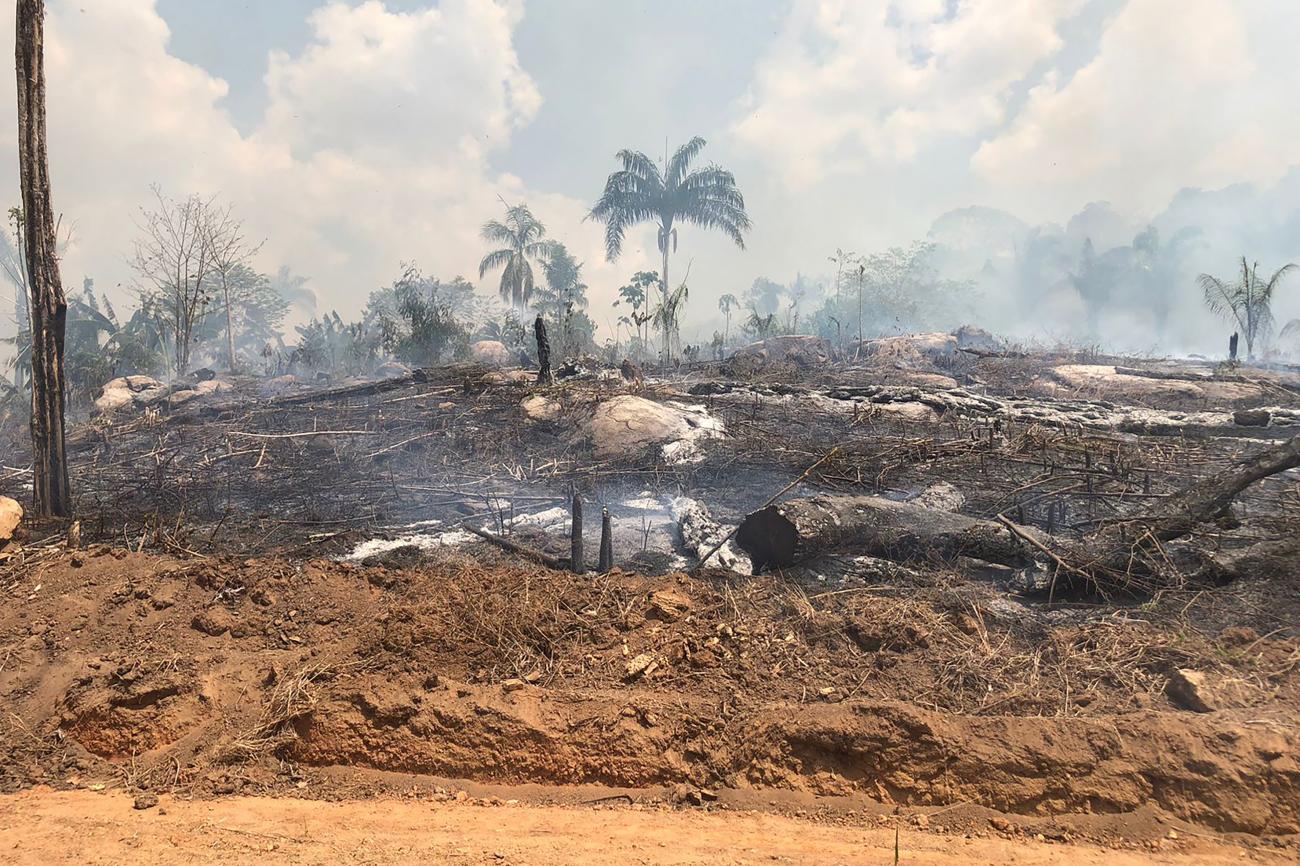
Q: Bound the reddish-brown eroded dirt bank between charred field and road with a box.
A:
[0,547,1300,835]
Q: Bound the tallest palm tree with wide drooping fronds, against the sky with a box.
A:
[589,135,750,351]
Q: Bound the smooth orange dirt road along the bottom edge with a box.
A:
[0,789,1286,866]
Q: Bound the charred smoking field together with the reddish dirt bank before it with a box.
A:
[0,338,1300,845]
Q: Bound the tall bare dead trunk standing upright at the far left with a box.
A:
[14,0,72,518]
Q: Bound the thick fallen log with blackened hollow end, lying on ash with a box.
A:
[736,495,1032,570]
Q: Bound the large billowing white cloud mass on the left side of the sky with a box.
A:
[0,0,650,331]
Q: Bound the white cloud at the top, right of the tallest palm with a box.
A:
[735,0,1083,185]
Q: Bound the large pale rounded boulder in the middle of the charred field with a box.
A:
[584,394,723,463]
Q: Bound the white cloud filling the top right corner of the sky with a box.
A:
[972,0,1300,213]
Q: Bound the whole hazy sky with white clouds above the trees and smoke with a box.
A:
[0,0,1300,343]
